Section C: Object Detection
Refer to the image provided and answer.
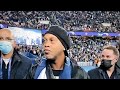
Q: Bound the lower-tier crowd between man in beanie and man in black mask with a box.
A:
[68,36,119,62]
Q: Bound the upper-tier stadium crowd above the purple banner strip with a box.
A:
[0,11,120,32]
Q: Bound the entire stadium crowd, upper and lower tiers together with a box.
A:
[0,11,120,62]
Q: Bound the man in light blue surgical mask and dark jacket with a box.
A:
[0,28,32,79]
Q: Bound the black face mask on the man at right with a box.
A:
[100,59,113,70]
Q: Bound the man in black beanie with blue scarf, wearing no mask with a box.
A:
[34,26,89,79]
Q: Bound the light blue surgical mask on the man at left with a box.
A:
[0,41,13,54]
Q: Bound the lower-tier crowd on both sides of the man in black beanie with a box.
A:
[16,36,119,62]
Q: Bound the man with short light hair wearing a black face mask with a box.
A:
[88,46,120,79]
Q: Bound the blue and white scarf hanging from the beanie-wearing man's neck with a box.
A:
[34,57,71,79]
